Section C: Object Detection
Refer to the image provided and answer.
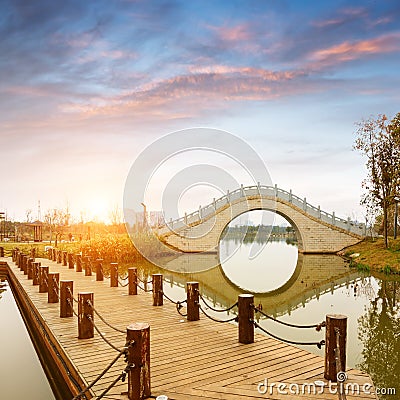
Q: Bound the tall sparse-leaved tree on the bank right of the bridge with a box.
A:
[354,113,400,248]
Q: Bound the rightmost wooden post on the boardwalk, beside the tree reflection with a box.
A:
[324,314,347,382]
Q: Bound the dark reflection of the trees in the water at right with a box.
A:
[358,281,400,399]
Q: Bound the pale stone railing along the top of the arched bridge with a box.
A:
[159,184,366,236]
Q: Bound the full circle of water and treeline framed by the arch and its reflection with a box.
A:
[219,211,298,293]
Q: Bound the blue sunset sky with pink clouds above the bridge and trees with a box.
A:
[0,0,400,220]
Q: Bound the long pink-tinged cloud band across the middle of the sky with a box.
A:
[60,65,305,119]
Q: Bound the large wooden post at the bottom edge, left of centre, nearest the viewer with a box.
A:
[126,323,151,400]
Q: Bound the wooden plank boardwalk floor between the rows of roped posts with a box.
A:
[0,258,377,400]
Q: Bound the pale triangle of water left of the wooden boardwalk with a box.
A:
[0,279,55,400]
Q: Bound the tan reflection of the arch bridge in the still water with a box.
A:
[148,253,360,315]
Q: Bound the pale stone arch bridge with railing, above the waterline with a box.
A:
[157,185,366,253]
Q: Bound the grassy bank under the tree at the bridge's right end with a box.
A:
[342,238,400,275]
